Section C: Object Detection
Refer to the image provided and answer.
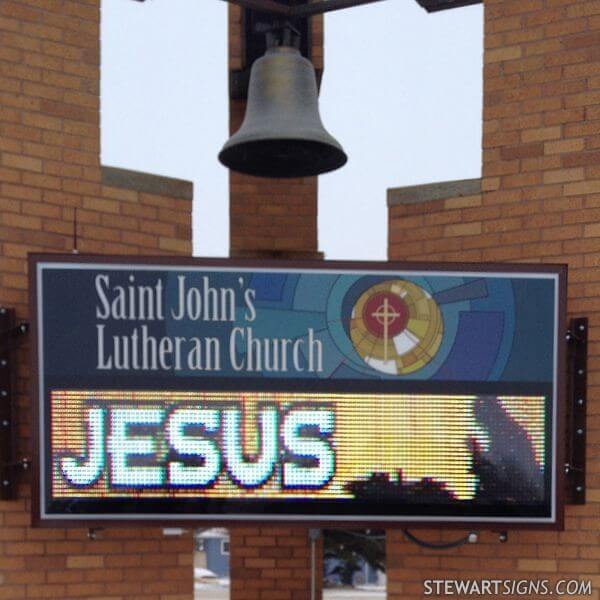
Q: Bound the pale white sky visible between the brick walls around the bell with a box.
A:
[102,0,483,260]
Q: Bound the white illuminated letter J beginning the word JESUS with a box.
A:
[59,408,104,486]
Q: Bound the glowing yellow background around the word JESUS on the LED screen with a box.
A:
[51,391,545,500]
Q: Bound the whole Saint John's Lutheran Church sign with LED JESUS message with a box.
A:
[32,256,564,526]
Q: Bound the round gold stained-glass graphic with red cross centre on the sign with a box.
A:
[350,279,444,375]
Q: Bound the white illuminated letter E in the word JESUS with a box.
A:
[108,408,165,487]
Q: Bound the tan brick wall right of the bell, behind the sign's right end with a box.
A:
[388,0,600,600]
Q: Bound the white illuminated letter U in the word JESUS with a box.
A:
[223,407,278,487]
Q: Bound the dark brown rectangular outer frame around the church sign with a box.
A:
[29,253,567,531]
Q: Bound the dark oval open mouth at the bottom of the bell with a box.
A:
[219,139,348,178]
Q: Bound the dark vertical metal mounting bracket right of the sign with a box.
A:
[565,317,588,504]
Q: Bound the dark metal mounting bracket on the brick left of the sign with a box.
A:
[0,308,30,500]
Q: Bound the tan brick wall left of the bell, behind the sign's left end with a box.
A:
[0,0,192,600]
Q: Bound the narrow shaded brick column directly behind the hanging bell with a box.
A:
[229,6,323,600]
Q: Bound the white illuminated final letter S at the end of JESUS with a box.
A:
[283,409,335,488]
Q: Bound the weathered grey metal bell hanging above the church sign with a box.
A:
[219,46,348,177]
